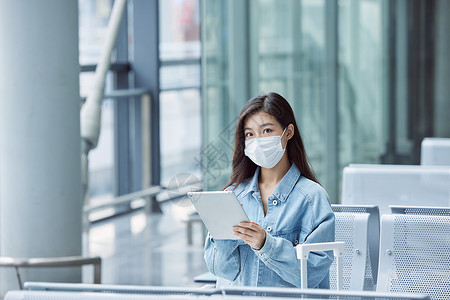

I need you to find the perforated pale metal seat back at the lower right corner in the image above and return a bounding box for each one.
[377,212,450,299]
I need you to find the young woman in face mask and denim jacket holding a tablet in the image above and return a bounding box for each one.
[205,93,334,288]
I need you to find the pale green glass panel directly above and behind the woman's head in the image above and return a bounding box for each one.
[251,0,330,195]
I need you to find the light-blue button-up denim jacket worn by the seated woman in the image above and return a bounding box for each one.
[205,164,334,288]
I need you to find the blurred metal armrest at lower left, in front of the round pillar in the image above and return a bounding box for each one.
[0,256,102,290]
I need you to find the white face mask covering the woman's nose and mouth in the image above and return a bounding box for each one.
[244,128,287,169]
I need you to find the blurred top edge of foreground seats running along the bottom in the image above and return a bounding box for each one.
[12,283,430,300]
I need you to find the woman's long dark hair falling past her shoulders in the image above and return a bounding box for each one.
[227,93,319,187]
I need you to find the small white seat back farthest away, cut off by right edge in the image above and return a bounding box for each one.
[420,138,450,166]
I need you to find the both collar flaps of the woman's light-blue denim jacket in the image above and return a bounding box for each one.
[243,163,301,202]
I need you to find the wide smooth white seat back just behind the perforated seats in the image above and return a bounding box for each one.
[342,164,450,214]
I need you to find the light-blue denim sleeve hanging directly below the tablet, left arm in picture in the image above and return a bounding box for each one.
[204,234,241,281]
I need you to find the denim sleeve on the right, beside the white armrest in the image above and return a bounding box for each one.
[254,190,334,288]
